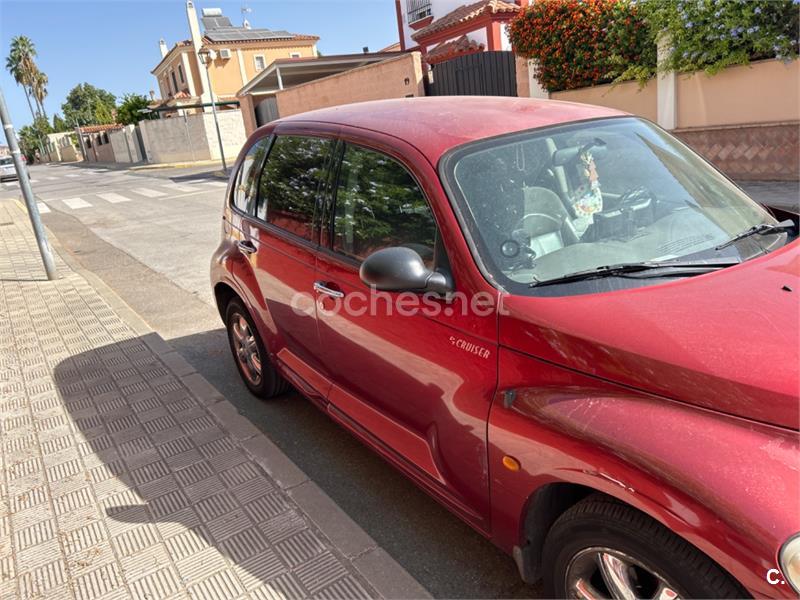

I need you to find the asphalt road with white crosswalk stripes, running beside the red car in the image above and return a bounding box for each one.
[0,165,540,598]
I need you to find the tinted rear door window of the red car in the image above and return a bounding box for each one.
[256,135,331,240]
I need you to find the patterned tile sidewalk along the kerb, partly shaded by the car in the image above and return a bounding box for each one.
[0,201,429,600]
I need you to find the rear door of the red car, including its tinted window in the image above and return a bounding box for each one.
[240,130,334,400]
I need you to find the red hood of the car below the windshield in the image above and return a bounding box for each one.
[500,241,800,429]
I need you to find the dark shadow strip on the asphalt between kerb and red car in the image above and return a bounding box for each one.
[163,327,541,598]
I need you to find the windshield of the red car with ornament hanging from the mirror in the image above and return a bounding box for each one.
[442,118,786,293]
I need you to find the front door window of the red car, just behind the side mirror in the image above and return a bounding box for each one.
[333,145,436,267]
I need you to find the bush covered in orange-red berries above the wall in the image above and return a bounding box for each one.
[508,0,656,92]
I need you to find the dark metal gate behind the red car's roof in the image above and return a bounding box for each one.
[425,52,517,96]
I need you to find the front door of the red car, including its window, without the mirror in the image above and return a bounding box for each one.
[316,138,497,530]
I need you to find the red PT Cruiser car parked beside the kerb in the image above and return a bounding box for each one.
[211,97,800,600]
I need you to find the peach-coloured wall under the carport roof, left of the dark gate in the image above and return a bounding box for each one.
[275,52,425,117]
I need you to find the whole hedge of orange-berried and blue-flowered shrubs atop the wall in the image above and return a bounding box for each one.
[508,0,800,92]
